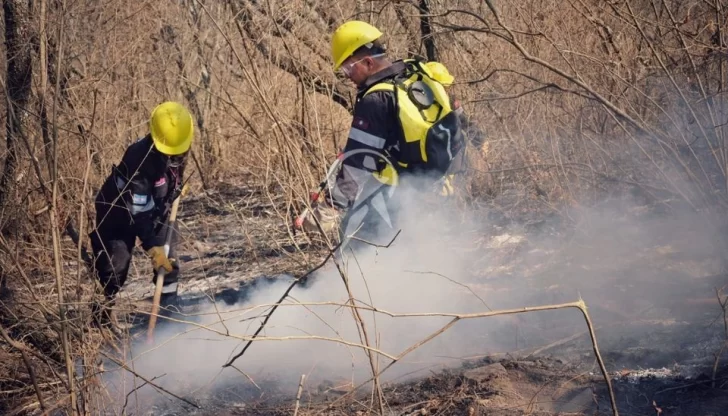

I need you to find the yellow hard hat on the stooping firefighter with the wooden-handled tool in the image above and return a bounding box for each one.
[149,101,195,156]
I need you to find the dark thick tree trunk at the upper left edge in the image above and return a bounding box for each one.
[0,0,33,206]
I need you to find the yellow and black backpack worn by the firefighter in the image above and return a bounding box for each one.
[365,59,465,174]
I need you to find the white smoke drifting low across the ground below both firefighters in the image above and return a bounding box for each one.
[98,172,725,412]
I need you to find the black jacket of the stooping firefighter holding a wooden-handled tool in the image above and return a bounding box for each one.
[96,135,184,250]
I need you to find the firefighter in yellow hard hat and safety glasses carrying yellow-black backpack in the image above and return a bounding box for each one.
[331,21,465,250]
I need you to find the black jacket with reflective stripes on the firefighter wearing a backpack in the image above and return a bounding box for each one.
[334,60,484,205]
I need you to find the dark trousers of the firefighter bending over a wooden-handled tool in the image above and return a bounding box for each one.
[89,206,179,300]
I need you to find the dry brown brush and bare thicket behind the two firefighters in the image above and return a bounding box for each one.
[0,0,728,413]
